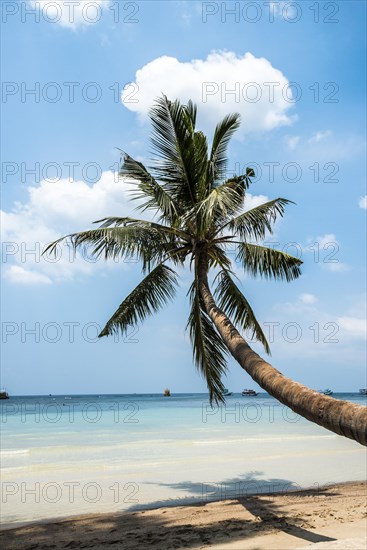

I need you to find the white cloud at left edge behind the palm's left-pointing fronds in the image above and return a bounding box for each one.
[1,172,136,284]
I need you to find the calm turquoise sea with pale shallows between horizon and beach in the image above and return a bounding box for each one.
[0,393,366,523]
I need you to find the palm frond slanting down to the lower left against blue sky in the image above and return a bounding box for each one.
[99,264,177,337]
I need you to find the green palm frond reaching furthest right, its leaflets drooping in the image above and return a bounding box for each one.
[236,243,303,281]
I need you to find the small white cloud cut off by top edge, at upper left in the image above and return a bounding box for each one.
[29,0,111,29]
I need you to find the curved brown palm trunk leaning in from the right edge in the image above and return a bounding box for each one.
[198,251,367,445]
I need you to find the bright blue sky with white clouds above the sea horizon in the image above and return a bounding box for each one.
[1,0,366,394]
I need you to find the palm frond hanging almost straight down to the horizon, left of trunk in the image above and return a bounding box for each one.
[186,282,228,404]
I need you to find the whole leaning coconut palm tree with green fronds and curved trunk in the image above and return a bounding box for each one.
[46,96,367,445]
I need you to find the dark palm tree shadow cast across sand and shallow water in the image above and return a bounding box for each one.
[0,472,338,550]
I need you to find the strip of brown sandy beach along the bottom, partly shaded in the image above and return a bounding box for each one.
[0,482,367,550]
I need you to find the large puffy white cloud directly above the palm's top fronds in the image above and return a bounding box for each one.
[121,51,294,133]
